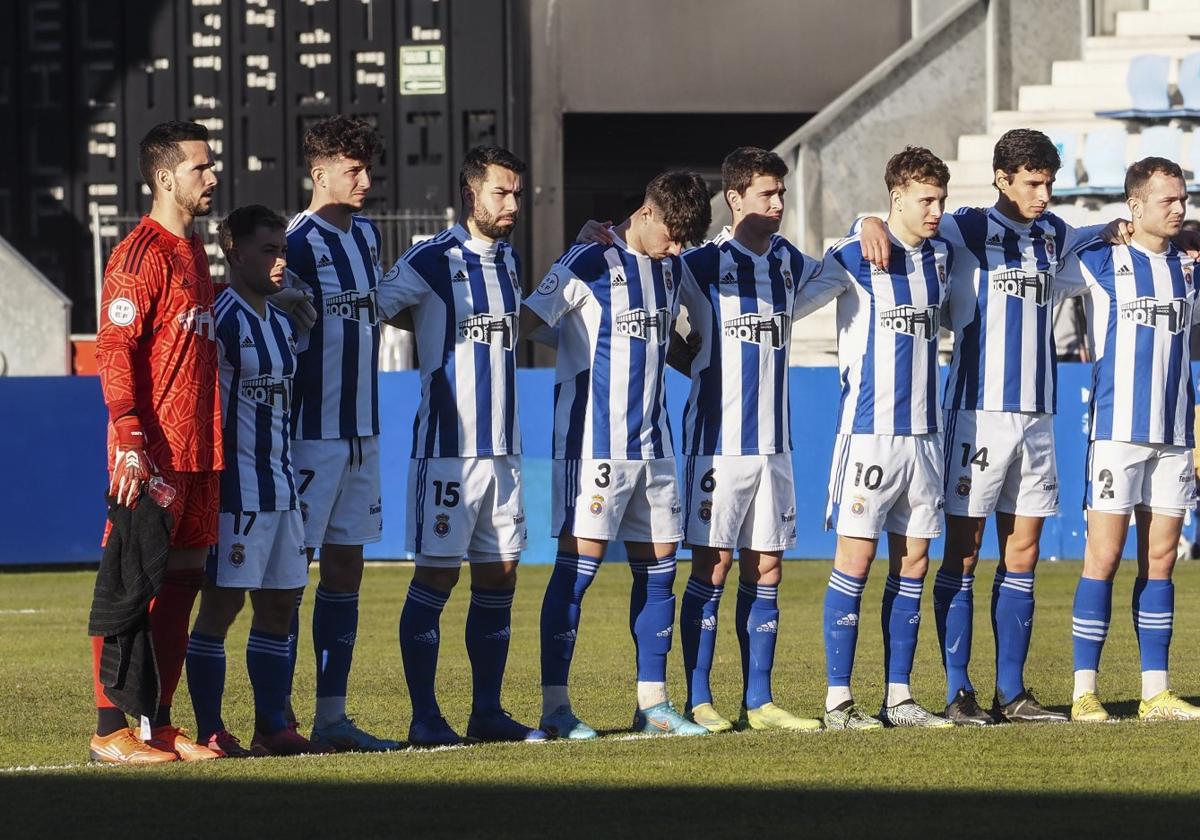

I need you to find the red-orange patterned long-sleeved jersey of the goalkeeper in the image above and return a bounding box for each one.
[96,216,223,472]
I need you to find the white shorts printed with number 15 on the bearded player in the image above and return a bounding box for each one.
[404,455,526,566]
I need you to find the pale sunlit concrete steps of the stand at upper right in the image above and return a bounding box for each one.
[791,0,1200,365]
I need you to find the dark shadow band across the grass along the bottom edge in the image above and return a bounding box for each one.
[0,768,1200,840]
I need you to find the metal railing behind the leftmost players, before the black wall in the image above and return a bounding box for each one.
[90,204,455,333]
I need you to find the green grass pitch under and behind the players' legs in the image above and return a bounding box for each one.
[0,563,1200,839]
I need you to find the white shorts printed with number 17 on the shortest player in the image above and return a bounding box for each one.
[206,510,308,589]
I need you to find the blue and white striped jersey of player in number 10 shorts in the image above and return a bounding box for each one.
[796,226,954,434]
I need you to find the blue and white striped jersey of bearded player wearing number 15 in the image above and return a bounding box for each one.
[378,224,521,458]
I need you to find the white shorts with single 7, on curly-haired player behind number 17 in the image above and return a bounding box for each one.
[292,436,383,548]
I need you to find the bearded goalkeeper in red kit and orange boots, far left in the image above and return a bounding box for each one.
[90,122,223,763]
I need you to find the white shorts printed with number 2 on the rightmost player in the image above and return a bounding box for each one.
[1087,440,1196,516]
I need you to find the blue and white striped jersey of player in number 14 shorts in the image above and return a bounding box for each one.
[938,208,1099,414]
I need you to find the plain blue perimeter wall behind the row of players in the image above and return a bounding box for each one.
[0,364,1161,565]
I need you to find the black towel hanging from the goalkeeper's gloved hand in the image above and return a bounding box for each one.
[88,494,172,718]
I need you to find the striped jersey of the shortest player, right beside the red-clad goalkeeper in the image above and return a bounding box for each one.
[216,288,296,514]
